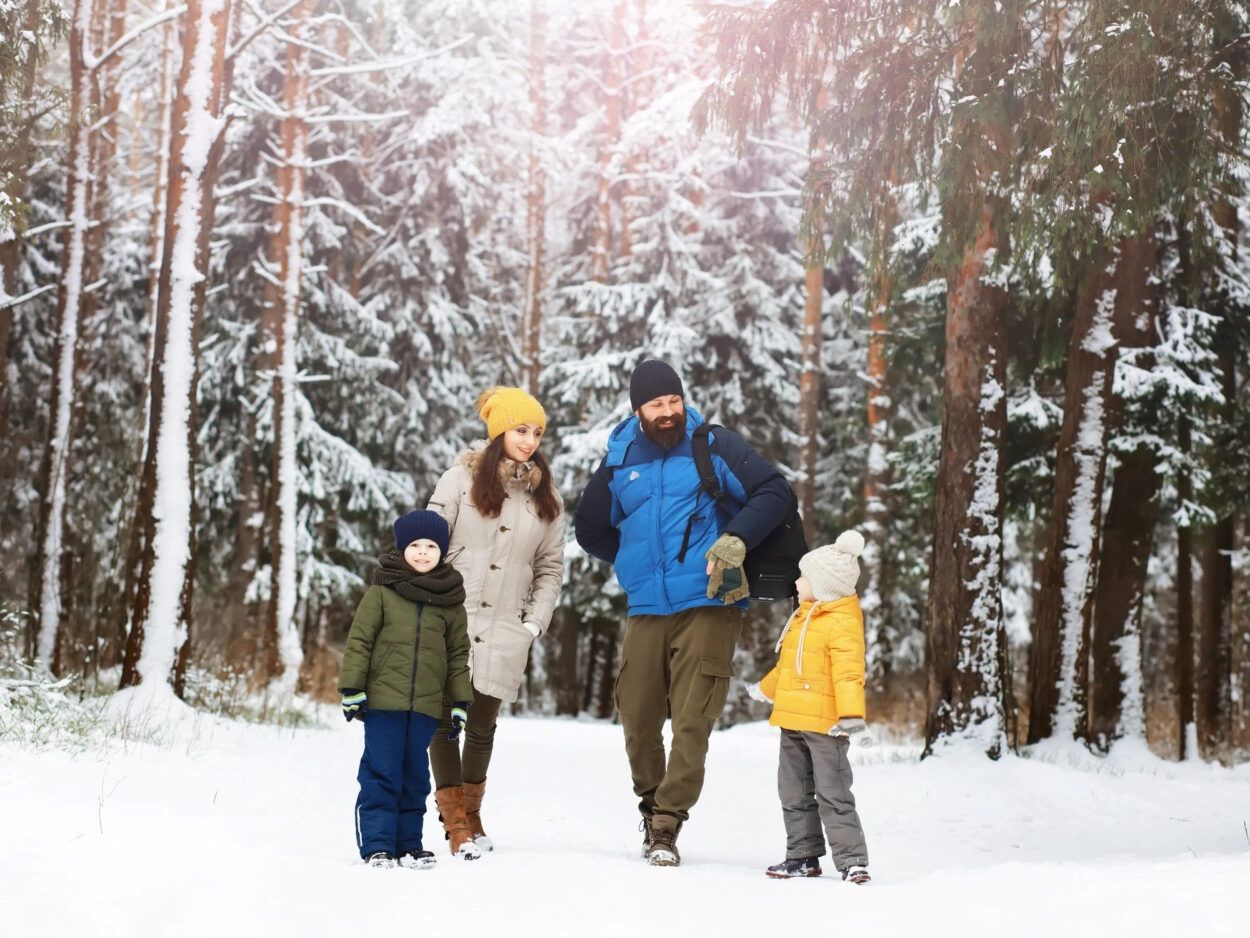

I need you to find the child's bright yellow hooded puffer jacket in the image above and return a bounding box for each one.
[760,594,868,733]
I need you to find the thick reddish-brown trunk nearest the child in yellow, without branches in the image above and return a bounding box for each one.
[925,1,1019,758]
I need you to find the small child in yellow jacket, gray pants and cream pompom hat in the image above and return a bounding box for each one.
[750,530,871,885]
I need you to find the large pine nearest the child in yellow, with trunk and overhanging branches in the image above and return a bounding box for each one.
[708,0,1038,755]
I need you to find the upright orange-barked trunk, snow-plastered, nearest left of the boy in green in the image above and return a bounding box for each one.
[265,0,309,700]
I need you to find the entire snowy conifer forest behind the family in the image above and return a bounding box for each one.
[0,0,1250,762]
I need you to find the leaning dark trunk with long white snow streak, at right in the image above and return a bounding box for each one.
[1028,249,1119,743]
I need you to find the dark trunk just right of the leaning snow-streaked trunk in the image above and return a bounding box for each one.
[1085,233,1161,750]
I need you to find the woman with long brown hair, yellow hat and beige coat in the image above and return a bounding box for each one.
[430,388,565,859]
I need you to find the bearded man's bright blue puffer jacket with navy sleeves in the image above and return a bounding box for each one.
[574,406,791,615]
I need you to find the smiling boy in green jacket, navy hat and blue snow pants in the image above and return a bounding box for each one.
[339,512,473,869]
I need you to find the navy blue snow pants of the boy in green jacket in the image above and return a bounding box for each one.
[356,710,439,858]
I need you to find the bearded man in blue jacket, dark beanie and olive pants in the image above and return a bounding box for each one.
[574,360,793,867]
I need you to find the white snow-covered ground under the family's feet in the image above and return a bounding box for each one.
[0,709,1250,938]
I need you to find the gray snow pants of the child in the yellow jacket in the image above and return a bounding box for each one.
[778,729,868,870]
